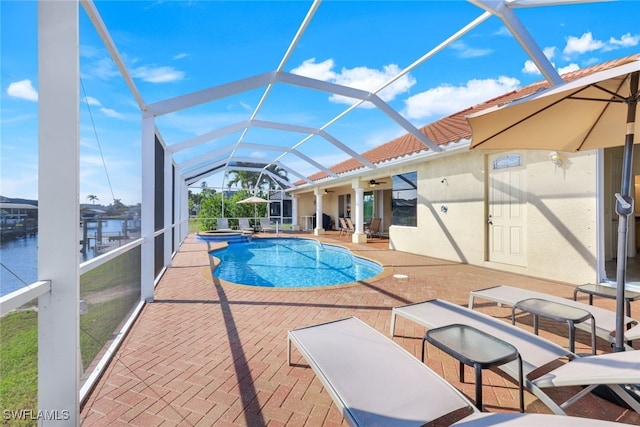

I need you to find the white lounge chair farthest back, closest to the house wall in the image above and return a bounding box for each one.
[469,285,640,349]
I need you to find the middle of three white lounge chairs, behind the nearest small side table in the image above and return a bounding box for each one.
[391,299,640,415]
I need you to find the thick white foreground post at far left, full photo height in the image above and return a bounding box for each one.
[38,1,82,425]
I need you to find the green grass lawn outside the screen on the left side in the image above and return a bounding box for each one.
[0,249,140,420]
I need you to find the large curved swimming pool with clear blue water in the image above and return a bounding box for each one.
[211,238,382,288]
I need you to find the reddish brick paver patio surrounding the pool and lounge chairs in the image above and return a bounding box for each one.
[82,233,640,426]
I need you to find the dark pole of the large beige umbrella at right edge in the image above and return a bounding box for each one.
[613,72,638,352]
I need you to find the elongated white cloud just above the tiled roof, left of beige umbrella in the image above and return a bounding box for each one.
[405,76,520,120]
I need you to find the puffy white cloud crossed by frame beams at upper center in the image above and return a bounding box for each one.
[291,58,416,107]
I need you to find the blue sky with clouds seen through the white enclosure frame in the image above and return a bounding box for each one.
[0,0,640,204]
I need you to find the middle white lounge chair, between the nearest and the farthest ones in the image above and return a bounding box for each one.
[391,299,640,415]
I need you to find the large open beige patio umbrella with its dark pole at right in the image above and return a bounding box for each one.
[467,60,640,351]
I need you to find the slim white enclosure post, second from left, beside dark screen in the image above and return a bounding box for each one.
[140,117,156,302]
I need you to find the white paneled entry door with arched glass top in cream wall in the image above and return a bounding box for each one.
[487,154,527,266]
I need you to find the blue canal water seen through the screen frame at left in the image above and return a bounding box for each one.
[0,219,138,296]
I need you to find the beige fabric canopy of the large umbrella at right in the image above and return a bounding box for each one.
[467,60,640,152]
